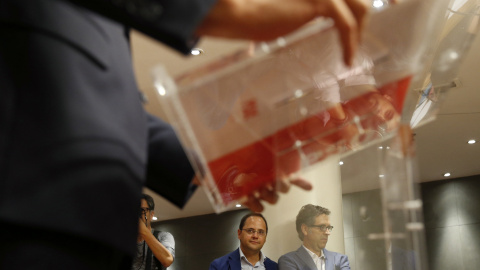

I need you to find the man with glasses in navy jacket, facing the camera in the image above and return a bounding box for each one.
[209,213,278,270]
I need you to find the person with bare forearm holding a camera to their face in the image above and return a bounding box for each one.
[131,194,175,270]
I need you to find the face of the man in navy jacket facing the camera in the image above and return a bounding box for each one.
[238,216,267,253]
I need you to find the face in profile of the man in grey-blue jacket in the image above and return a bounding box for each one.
[302,214,330,253]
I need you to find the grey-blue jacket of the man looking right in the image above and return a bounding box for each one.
[278,246,350,270]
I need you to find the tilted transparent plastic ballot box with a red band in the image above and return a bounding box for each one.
[154,0,450,212]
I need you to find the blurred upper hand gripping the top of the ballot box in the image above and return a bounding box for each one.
[196,0,369,66]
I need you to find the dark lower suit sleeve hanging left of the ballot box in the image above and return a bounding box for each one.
[146,114,196,207]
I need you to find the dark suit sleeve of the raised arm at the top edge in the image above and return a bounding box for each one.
[64,0,217,54]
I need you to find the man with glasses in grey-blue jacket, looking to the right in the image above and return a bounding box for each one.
[278,204,350,270]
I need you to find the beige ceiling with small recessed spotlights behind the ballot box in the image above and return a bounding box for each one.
[132,7,480,220]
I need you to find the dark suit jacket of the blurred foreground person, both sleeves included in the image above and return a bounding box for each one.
[0,0,214,254]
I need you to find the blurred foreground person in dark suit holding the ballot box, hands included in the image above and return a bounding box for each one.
[0,0,367,270]
